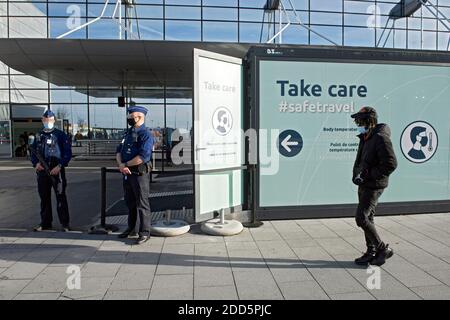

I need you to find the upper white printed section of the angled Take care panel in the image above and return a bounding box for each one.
[194,51,243,170]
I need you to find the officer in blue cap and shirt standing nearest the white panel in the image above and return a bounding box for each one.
[116,106,153,244]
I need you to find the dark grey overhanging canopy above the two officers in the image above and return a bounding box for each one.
[0,39,251,88]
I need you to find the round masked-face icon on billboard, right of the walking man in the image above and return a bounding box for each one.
[400,121,438,163]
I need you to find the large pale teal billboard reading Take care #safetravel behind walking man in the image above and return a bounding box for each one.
[253,46,450,217]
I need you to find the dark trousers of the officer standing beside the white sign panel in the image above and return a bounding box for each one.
[123,172,151,236]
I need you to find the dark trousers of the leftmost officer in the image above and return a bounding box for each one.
[37,168,70,228]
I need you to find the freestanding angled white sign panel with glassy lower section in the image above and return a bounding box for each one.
[194,50,244,221]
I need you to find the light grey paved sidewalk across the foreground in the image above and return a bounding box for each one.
[0,214,450,300]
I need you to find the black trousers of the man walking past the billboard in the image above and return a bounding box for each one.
[355,186,384,250]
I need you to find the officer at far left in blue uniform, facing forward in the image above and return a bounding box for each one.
[31,110,72,231]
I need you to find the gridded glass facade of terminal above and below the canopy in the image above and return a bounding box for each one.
[0,0,450,155]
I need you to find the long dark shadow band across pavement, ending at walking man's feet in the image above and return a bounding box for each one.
[0,230,365,269]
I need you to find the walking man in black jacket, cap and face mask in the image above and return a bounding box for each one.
[351,107,397,266]
